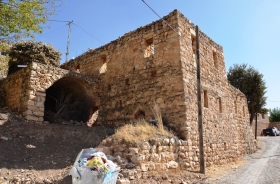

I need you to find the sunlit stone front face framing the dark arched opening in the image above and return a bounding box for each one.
[23,62,99,122]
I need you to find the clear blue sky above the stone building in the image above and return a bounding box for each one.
[35,0,280,108]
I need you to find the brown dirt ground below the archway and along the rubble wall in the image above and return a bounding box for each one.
[0,109,210,184]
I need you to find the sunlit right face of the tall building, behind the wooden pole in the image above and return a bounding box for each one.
[179,13,255,165]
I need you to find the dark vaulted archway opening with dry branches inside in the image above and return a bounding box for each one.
[44,77,98,123]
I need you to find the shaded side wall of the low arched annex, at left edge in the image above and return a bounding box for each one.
[0,66,31,113]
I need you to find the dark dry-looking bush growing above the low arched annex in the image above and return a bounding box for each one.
[8,41,61,75]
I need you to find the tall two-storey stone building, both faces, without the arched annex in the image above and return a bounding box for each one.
[62,10,256,165]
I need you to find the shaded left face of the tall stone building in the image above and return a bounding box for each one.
[62,11,186,130]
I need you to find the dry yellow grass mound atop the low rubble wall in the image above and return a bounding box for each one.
[114,120,175,143]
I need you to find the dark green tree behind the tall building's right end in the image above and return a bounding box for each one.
[227,64,266,124]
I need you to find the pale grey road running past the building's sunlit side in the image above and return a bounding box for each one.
[211,136,280,184]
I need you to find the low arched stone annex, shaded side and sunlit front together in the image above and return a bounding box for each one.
[0,62,99,122]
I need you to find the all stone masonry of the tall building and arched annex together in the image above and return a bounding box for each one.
[0,10,256,171]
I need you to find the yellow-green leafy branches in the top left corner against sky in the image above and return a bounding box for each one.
[0,0,61,42]
